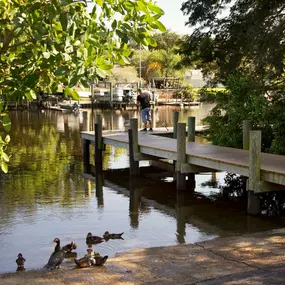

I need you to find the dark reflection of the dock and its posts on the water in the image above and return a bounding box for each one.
[84,167,274,243]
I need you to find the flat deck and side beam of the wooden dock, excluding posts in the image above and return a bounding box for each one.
[82,130,285,185]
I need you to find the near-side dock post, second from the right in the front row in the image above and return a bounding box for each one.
[175,123,186,190]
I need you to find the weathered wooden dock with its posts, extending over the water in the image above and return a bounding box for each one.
[82,112,285,214]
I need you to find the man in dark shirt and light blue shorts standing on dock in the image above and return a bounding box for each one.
[137,89,153,132]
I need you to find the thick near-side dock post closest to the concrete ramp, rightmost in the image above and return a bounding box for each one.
[247,131,261,215]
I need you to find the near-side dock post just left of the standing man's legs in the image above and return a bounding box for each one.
[128,118,140,175]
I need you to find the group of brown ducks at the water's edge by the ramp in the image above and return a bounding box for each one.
[16,232,123,271]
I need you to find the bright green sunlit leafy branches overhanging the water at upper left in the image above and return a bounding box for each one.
[0,0,165,172]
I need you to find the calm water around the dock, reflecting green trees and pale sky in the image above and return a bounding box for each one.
[0,105,279,273]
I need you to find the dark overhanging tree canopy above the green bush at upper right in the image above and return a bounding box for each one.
[181,0,285,84]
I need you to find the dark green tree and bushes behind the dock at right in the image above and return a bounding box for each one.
[180,0,285,154]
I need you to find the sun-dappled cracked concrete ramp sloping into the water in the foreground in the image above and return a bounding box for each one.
[0,229,285,285]
